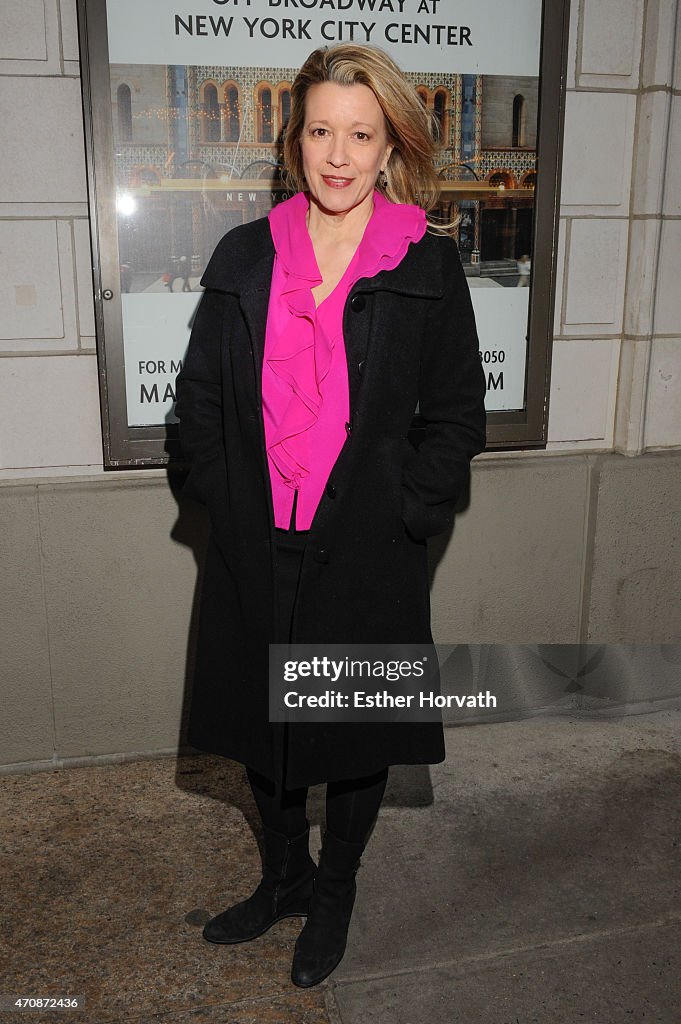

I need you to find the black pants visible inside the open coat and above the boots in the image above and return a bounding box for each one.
[247,512,388,843]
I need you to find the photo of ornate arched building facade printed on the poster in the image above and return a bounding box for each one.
[111,65,539,293]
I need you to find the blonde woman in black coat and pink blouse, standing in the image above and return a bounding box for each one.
[177,44,485,986]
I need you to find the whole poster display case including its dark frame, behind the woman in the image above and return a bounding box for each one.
[79,0,567,466]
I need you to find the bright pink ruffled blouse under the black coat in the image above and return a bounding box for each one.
[262,191,426,529]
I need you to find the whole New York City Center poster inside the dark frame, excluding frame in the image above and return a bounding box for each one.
[99,0,542,427]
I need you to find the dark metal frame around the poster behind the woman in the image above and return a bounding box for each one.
[78,0,569,469]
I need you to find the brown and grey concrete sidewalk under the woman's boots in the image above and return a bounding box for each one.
[0,712,681,1024]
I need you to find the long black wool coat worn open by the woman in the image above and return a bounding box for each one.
[176,211,485,787]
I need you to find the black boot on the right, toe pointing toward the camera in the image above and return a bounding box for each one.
[291,829,366,988]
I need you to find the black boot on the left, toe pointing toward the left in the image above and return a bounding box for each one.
[204,825,316,944]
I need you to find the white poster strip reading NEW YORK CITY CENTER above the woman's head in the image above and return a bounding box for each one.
[108,0,542,76]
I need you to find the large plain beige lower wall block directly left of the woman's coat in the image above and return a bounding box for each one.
[41,476,201,757]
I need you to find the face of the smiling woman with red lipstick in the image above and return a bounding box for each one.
[301,82,392,215]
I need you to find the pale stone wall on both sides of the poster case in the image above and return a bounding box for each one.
[0,0,681,767]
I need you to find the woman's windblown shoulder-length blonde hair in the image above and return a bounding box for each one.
[284,43,439,211]
